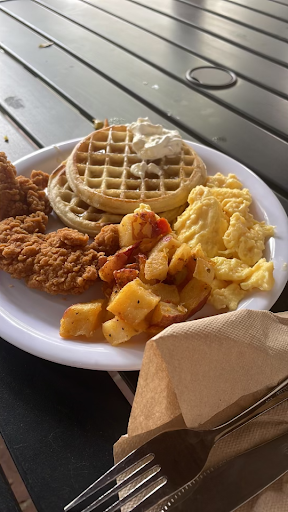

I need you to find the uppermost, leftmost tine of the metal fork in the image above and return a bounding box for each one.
[64,446,154,512]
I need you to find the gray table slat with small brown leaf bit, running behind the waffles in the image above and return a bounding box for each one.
[0,15,195,140]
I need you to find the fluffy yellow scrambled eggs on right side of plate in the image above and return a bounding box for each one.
[174,173,274,310]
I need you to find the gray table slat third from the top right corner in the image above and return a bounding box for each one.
[130,0,287,58]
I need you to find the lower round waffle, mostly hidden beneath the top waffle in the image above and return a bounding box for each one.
[48,162,186,236]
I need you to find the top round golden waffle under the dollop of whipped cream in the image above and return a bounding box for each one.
[66,125,206,215]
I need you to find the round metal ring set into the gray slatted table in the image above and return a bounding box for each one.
[186,66,237,89]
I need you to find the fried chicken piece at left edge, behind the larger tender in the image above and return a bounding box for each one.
[0,152,52,221]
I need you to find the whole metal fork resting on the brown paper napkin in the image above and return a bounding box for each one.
[64,378,288,512]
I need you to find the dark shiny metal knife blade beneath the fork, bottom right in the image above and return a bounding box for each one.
[157,432,288,512]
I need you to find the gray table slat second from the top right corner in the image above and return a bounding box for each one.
[177,0,288,37]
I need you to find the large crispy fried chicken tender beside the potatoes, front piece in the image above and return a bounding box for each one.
[0,212,103,295]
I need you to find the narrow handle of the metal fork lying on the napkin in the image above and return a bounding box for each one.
[212,379,288,443]
